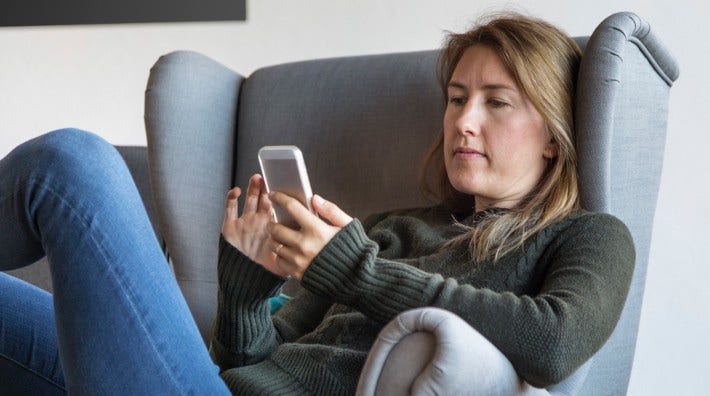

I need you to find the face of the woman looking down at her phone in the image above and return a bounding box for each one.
[444,45,557,211]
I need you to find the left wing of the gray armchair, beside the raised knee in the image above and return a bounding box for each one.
[145,51,242,342]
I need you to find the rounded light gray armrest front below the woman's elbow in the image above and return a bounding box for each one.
[357,308,546,395]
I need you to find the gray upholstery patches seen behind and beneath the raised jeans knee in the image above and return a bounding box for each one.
[7,146,163,292]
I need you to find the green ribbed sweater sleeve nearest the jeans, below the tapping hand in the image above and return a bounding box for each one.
[210,238,284,370]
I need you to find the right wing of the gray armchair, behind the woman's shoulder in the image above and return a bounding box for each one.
[576,13,678,395]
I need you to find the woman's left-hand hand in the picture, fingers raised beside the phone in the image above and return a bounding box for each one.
[222,174,288,277]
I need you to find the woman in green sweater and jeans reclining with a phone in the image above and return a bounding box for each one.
[0,12,634,395]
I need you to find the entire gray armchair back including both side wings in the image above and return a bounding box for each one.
[145,10,677,394]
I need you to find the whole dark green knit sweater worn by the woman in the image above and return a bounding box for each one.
[210,207,634,395]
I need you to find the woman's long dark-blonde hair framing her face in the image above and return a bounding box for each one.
[422,14,581,261]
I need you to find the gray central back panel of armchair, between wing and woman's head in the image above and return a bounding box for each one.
[235,51,444,218]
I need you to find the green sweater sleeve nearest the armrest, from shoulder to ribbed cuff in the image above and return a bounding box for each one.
[302,215,634,387]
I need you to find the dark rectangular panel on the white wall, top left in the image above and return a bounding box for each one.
[0,0,246,26]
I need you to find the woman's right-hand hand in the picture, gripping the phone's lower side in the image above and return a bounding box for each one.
[268,192,352,280]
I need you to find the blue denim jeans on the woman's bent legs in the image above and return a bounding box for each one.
[0,129,229,395]
